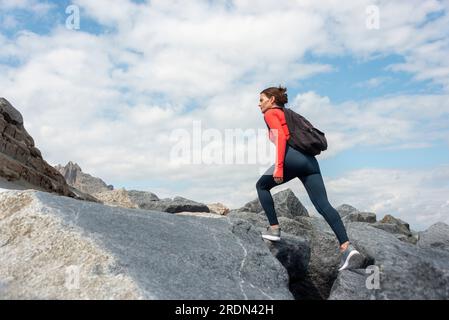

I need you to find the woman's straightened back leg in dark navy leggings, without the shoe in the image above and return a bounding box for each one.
[299,173,349,245]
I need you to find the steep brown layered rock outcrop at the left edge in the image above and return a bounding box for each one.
[0,98,75,197]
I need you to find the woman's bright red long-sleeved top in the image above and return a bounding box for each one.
[264,108,290,177]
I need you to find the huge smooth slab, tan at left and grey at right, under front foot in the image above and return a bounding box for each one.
[0,190,293,300]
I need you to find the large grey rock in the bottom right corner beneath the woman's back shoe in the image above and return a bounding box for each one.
[329,222,449,300]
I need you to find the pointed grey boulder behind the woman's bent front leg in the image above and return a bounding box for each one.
[231,189,309,218]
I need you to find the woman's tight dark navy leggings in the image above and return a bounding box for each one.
[256,144,348,244]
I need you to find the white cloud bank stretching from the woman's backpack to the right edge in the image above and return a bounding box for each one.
[292,92,449,159]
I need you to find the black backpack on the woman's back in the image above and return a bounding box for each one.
[267,107,327,156]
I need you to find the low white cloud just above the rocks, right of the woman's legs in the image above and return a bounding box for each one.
[326,165,449,230]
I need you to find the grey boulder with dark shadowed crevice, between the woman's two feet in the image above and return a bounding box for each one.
[229,205,354,300]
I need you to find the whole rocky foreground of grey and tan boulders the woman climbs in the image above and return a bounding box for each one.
[0,185,449,299]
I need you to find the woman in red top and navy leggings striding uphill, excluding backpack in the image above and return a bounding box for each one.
[256,86,361,271]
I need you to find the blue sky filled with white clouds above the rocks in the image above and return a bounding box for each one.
[0,0,449,230]
